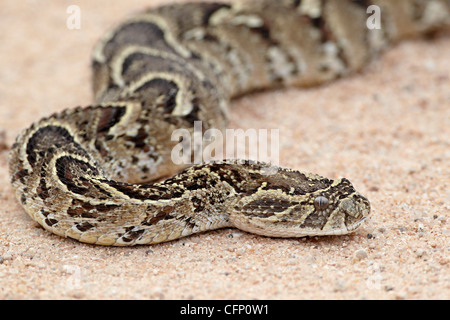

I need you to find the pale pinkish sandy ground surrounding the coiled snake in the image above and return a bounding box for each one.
[0,0,450,299]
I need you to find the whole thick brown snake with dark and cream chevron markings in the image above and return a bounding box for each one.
[9,0,450,246]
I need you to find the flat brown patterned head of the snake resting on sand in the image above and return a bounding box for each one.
[230,171,370,237]
